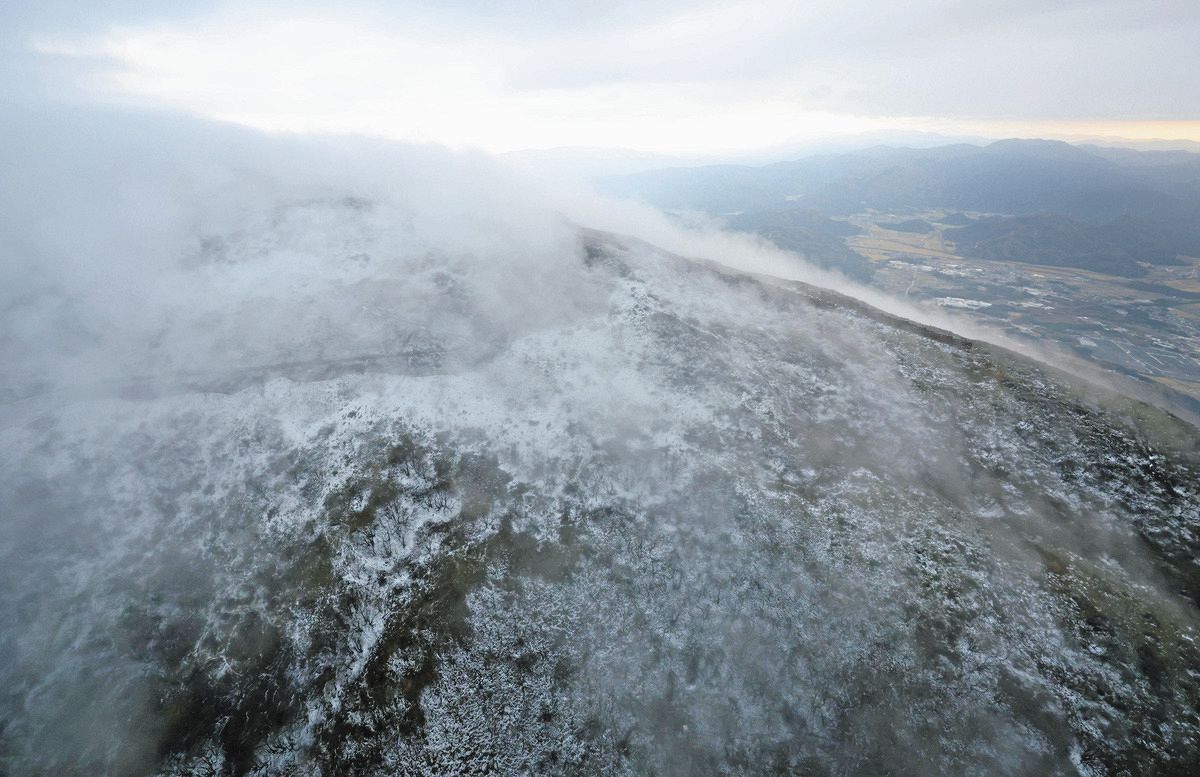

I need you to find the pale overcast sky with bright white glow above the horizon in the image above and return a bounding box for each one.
[0,0,1200,153]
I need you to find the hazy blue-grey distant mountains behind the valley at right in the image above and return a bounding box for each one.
[599,140,1200,277]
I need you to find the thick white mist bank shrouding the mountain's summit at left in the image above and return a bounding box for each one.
[0,102,600,402]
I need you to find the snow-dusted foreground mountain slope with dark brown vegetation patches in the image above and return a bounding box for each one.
[0,199,1200,775]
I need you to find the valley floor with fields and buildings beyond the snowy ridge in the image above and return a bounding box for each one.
[846,211,1200,410]
